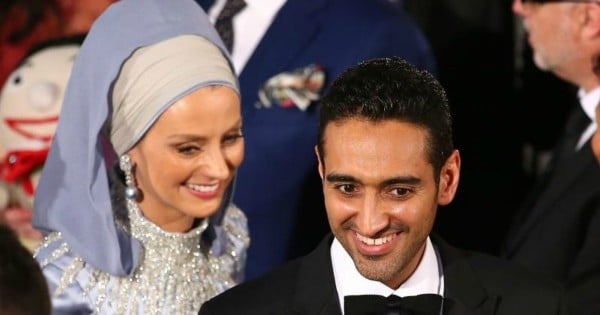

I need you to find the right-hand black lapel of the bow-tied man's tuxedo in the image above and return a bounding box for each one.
[431,235,499,315]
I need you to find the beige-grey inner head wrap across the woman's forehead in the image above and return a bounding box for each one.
[110,35,237,156]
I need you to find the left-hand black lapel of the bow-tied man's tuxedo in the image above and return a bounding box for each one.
[290,234,342,315]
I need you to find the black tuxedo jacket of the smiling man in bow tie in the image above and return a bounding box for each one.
[199,234,566,315]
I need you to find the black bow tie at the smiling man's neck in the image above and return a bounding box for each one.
[344,294,442,315]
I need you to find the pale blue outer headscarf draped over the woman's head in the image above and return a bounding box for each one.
[33,0,238,276]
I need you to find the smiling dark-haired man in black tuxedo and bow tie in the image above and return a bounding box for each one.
[200,58,564,315]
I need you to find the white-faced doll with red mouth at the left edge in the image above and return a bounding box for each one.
[0,36,83,248]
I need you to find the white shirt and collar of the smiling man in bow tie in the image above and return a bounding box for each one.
[331,238,444,312]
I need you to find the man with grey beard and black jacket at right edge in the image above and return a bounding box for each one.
[501,0,600,315]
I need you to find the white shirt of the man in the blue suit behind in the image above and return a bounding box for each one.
[207,0,285,75]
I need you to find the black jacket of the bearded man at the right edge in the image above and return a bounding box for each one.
[502,141,600,315]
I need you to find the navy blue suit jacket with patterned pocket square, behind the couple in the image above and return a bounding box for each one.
[197,0,435,279]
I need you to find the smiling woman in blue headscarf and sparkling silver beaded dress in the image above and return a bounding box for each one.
[33,0,249,314]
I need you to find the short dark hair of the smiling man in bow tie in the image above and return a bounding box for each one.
[318,58,454,180]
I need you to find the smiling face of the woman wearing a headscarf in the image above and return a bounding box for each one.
[128,86,244,232]
